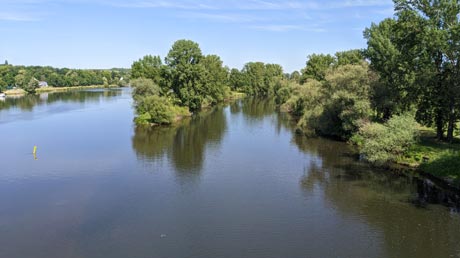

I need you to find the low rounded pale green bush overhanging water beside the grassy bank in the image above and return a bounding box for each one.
[351,113,419,165]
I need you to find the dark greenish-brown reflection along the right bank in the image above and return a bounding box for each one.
[294,136,460,257]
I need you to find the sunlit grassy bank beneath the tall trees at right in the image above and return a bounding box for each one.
[398,128,460,185]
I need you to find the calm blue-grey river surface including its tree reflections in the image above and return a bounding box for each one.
[0,90,460,258]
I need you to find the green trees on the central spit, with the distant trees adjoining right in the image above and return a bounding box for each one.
[131,40,284,124]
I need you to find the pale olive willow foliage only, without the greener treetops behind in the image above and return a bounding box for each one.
[277,61,372,139]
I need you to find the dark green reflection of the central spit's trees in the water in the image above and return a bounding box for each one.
[132,106,227,176]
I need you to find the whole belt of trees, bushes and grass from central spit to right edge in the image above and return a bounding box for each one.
[132,0,460,184]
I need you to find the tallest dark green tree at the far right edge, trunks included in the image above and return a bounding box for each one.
[394,0,460,141]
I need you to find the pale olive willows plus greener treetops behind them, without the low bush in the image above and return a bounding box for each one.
[276,50,374,139]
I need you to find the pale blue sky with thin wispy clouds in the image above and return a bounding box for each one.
[0,0,393,72]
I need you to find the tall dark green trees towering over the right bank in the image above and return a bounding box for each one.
[364,0,460,142]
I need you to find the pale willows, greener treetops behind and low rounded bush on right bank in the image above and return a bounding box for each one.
[275,50,418,163]
